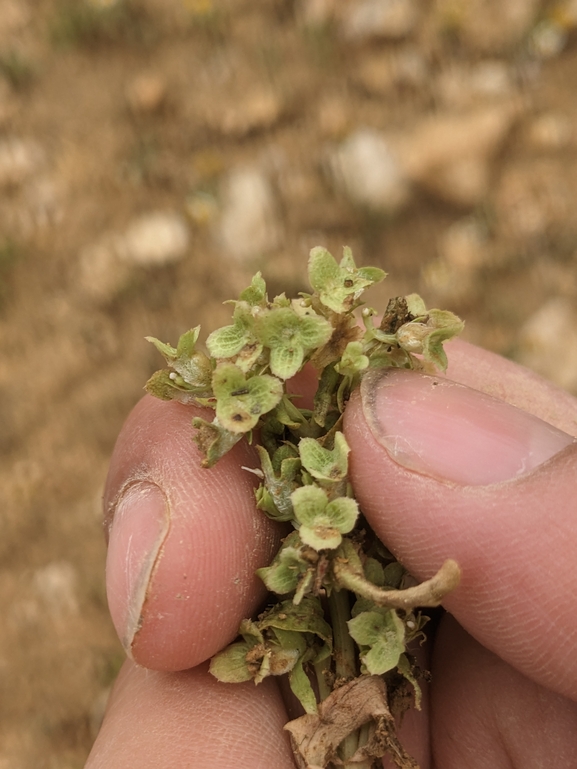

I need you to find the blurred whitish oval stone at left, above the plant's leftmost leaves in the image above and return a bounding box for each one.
[117,211,190,267]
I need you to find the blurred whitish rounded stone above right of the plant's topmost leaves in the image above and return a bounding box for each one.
[329,128,409,211]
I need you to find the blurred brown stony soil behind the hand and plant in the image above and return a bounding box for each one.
[0,0,577,769]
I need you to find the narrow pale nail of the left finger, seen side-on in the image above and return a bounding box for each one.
[106,481,170,656]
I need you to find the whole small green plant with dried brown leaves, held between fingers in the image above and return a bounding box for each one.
[146,246,463,769]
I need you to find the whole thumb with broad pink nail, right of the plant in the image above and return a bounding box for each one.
[345,353,577,698]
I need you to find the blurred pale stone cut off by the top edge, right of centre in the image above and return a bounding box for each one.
[341,0,420,41]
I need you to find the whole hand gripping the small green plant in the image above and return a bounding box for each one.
[87,341,577,769]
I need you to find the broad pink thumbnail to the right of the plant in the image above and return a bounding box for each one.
[361,369,575,486]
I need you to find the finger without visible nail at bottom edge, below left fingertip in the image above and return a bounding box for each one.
[86,661,294,769]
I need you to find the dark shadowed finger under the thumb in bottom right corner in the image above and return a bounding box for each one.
[431,616,577,769]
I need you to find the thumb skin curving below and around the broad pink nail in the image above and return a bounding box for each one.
[345,346,577,698]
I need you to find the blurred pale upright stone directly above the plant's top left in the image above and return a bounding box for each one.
[216,166,281,260]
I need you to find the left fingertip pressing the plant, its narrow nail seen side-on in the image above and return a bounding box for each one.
[104,396,281,670]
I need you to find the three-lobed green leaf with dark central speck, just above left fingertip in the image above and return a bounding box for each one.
[212,363,284,433]
